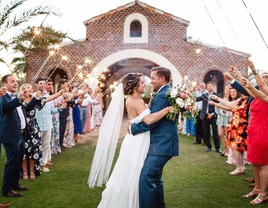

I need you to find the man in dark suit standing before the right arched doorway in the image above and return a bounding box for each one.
[196,82,222,153]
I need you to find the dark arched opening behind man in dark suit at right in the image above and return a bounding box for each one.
[204,70,224,95]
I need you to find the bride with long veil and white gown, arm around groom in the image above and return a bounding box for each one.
[88,73,174,208]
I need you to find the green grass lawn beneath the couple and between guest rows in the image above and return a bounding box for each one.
[0,135,267,208]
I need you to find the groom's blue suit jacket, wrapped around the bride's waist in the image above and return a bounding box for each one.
[131,85,179,156]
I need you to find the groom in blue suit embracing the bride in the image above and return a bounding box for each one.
[130,67,179,208]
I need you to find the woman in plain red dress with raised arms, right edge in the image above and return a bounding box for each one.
[238,66,268,204]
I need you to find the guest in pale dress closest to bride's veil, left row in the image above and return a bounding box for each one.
[91,88,104,129]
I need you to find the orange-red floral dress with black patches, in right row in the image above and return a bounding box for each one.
[227,103,248,152]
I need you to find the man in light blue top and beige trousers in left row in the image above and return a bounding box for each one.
[33,78,66,172]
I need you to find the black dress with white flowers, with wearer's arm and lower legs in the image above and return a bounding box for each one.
[23,98,46,176]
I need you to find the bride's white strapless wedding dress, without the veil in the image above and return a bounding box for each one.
[98,109,150,208]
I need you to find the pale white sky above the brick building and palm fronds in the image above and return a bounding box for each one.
[0,0,268,75]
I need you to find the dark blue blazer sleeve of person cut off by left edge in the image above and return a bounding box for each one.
[0,98,21,143]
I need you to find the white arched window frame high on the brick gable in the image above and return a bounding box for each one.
[124,13,148,43]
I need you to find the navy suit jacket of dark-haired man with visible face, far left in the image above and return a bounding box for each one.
[2,94,38,144]
